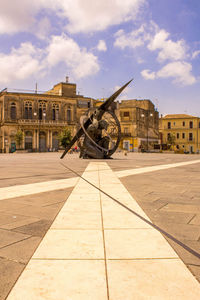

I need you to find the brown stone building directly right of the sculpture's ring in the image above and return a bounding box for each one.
[119,99,159,151]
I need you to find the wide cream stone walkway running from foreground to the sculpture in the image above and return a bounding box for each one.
[7,162,200,300]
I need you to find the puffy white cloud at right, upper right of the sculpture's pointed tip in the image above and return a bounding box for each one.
[148,29,187,62]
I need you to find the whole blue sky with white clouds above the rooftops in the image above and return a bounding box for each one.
[0,0,200,117]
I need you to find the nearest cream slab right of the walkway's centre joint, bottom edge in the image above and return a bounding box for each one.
[108,259,199,300]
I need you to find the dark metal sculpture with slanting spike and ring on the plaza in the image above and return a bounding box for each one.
[60,80,132,159]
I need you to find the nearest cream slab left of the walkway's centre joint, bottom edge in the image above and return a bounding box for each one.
[7,260,107,300]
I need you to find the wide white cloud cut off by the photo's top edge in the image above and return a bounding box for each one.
[0,0,146,34]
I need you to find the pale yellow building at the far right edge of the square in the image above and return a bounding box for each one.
[159,114,200,153]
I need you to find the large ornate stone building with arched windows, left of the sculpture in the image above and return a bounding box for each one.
[0,82,94,152]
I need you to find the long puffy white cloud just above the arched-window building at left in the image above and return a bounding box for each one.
[0,34,100,84]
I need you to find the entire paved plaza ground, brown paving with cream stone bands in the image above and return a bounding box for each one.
[0,153,200,300]
